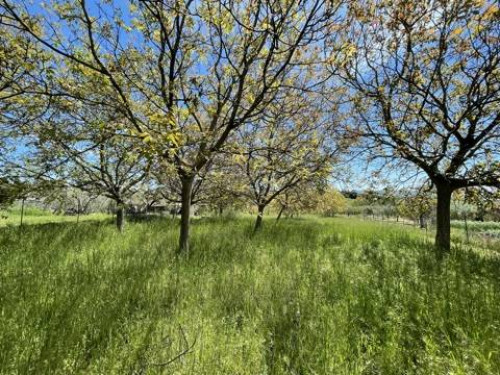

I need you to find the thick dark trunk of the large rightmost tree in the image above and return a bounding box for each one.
[436,183,453,253]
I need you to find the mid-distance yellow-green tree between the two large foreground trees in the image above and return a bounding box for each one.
[234,96,337,231]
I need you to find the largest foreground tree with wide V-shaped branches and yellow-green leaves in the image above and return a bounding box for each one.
[1,0,342,251]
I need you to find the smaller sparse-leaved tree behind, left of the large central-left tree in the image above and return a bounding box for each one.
[35,111,150,232]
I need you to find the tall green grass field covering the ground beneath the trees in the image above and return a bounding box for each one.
[0,218,500,374]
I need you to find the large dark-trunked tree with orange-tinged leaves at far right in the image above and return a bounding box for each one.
[332,0,500,254]
